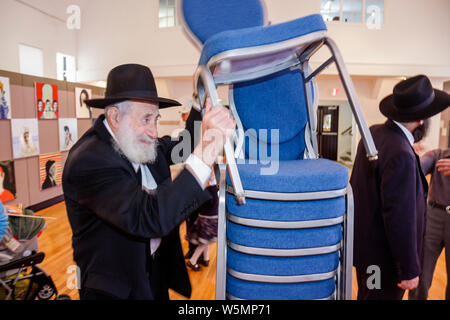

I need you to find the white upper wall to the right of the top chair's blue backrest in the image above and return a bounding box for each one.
[266,0,450,78]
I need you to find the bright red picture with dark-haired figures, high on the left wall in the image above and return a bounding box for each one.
[35,82,59,119]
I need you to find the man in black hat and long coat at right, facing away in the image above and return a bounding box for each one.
[350,75,450,300]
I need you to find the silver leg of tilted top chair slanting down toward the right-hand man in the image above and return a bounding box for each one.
[325,38,378,160]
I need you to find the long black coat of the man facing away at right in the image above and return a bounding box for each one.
[350,120,428,281]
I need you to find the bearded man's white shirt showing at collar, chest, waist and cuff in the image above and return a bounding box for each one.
[103,119,212,254]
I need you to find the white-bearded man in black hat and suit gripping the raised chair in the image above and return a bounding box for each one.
[63,64,235,299]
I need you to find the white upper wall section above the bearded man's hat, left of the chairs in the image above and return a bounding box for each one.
[78,0,199,81]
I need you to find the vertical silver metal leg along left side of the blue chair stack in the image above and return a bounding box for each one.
[216,164,227,300]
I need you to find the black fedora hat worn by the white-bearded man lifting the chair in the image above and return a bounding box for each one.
[85,64,181,109]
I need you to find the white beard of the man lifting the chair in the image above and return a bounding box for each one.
[114,119,158,163]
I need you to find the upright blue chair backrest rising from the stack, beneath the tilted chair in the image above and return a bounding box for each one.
[233,70,308,160]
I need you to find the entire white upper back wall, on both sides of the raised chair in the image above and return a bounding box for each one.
[78,0,450,81]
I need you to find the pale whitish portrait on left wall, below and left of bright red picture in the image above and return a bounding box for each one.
[11,119,39,159]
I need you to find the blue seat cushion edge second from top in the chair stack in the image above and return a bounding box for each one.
[226,193,346,221]
